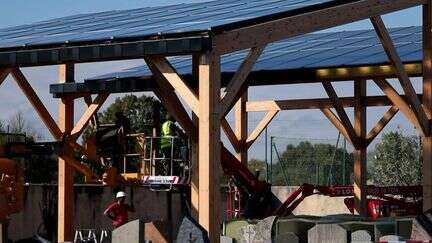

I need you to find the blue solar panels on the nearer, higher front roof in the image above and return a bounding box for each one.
[0,0,337,49]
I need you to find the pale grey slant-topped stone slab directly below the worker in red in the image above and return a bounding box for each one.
[111,219,144,243]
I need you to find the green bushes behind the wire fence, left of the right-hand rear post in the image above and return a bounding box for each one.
[271,142,354,185]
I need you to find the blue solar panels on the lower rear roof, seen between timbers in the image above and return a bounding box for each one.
[90,26,422,80]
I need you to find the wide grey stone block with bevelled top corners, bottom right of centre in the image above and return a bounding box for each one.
[308,224,348,243]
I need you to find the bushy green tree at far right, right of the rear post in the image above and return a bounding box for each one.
[371,131,422,186]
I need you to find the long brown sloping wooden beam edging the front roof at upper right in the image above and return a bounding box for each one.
[213,0,426,54]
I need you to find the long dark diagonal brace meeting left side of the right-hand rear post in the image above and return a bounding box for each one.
[322,82,358,147]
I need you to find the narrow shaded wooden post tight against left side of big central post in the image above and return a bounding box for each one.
[190,54,200,221]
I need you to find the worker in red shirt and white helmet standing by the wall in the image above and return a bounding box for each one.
[104,191,135,228]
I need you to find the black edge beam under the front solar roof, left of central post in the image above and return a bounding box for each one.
[0,36,211,68]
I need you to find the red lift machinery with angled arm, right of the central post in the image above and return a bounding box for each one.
[221,146,422,219]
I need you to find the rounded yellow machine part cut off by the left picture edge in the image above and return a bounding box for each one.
[0,158,24,222]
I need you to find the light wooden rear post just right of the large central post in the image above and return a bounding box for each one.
[234,89,248,165]
